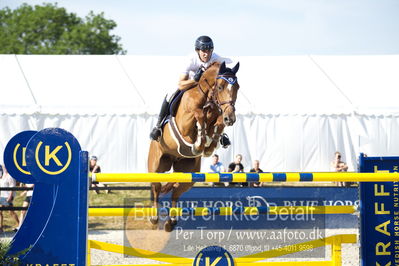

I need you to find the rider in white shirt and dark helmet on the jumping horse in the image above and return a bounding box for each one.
[150,36,232,148]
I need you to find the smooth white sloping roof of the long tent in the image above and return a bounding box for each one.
[0,55,399,115]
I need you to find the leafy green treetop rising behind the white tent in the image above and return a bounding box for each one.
[0,4,126,54]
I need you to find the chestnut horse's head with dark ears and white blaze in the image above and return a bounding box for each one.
[214,62,240,126]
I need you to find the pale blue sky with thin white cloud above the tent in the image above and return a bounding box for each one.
[0,0,399,56]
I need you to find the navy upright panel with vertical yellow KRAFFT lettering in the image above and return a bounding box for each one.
[360,154,399,265]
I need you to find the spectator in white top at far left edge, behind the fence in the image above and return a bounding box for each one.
[0,165,19,232]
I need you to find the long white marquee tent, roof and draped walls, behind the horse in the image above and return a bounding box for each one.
[0,55,399,172]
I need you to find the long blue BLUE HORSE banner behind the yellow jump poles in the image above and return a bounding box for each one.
[155,187,359,229]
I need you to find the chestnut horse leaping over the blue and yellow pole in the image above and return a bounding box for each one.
[148,62,240,232]
